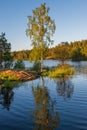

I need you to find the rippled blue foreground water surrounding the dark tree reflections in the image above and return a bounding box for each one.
[0,75,87,130]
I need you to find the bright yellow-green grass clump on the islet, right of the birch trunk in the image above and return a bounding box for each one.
[48,64,74,78]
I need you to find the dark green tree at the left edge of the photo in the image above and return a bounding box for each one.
[0,33,12,68]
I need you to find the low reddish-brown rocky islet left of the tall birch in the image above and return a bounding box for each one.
[0,69,38,81]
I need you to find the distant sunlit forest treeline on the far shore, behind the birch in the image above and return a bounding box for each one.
[11,40,87,61]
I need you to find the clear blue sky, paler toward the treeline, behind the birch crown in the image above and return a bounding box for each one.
[0,0,87,51]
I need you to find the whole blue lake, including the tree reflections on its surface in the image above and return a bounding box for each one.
[0,60,87,130]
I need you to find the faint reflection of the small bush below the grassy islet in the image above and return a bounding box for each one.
[55,77,74,99]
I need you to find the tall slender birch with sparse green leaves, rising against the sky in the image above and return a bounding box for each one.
[26,3,55,71]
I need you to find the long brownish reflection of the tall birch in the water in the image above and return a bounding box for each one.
[32,78,60,130]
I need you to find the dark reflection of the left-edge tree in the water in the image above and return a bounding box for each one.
[0,86,14,110]
